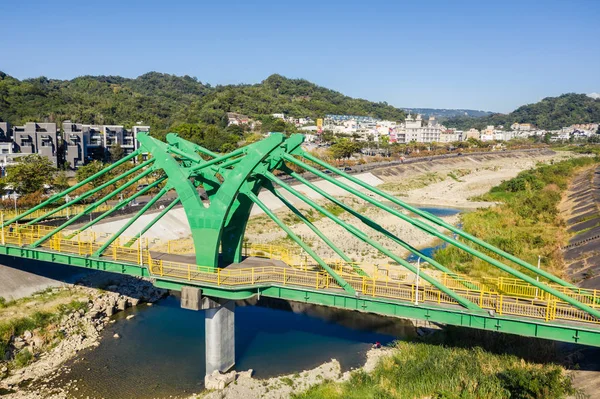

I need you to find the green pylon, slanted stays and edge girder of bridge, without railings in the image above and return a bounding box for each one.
[0,133,600,346]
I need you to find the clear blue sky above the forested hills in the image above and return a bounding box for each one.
[0,0,600,112]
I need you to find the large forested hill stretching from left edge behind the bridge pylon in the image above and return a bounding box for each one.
[0,72,404,131]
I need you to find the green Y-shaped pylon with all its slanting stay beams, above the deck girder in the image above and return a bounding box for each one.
[3,133,600,319]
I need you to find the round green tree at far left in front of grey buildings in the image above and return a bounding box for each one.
[6,154,57,195]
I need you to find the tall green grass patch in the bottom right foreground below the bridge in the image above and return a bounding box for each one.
[292,342,576,399]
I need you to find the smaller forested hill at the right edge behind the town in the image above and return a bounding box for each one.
[444,93,600,130]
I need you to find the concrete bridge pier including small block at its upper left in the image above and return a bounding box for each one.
[181,287,235,376]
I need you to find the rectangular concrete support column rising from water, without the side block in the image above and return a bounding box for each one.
[202,298,235,375]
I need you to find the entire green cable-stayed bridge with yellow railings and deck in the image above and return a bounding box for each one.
[0,133,600,371]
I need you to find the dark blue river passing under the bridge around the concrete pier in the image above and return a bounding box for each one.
[45,208,460,399]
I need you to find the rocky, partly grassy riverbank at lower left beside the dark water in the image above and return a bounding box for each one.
[0,273,167,399]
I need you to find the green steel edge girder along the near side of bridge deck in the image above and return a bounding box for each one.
[0,241,600,347]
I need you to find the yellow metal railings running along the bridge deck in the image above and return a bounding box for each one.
[1,225,600,323]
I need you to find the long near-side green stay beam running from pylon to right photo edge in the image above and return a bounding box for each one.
[283,154,600,320]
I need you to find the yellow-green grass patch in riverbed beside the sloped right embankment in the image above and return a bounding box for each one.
[434,157,600,277]
